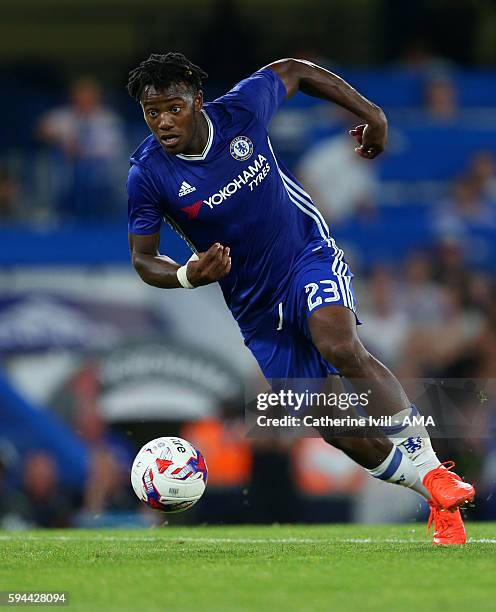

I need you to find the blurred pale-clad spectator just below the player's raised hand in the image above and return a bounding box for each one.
[296,113,378,225]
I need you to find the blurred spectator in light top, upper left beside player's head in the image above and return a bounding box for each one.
[38,78,127,219]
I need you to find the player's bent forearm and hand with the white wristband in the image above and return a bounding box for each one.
[129,233,231,289]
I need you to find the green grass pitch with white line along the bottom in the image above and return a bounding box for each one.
[0,523,496,612]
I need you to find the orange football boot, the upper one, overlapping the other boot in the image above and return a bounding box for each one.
[423,461,475,510]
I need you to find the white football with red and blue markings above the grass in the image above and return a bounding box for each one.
[131,437,207,512]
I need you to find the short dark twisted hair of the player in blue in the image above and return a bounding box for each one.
[127,52,208,102]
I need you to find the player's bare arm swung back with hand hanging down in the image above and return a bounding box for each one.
[265,58,387,159]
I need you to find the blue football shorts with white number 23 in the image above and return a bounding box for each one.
[241,241,360,379]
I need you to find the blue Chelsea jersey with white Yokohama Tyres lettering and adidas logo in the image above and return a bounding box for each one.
[127,69,342,329]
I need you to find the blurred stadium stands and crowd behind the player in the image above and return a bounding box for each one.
[0,0,496,529]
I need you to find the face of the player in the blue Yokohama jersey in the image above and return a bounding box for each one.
[141,83,203,155]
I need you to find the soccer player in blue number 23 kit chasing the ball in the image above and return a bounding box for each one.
[127,53,475,544]
